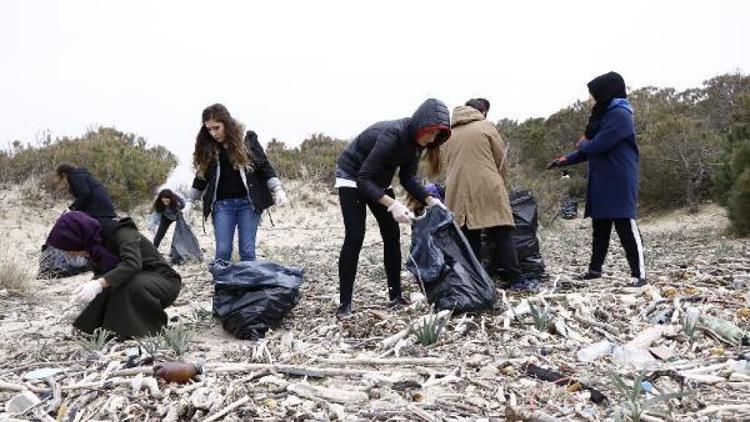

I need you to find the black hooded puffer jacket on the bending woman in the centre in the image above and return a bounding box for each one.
[337,98,450,203]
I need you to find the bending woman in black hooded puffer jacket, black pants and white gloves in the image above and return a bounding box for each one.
[335,98,450,317]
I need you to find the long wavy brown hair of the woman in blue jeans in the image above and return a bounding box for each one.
[193,104,252,178]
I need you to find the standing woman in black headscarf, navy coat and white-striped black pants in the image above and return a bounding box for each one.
[547,72,646,286]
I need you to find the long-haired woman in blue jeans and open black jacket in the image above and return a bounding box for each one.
[190,104,287,261]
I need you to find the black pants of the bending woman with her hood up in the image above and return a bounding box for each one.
[339,187,401,303]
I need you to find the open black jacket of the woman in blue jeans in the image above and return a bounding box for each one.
[191,130,277,218]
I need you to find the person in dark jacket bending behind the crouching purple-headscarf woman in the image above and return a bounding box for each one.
[56,164,116,220]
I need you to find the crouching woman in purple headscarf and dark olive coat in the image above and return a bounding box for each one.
[46,211,182,339]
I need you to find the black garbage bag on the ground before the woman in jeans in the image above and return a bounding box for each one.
[209,260,303,340]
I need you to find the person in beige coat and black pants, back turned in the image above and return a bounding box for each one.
[442,98,529,290]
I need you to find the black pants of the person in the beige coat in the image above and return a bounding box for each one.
[461,226,521,283]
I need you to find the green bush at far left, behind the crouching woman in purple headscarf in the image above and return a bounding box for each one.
[0,127,177,210]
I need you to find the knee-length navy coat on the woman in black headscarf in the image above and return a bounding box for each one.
[565,98,639,219]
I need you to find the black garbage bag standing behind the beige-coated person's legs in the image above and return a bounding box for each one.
[482,190,546,280]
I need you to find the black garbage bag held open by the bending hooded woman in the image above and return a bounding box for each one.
[406,207,495,313]
